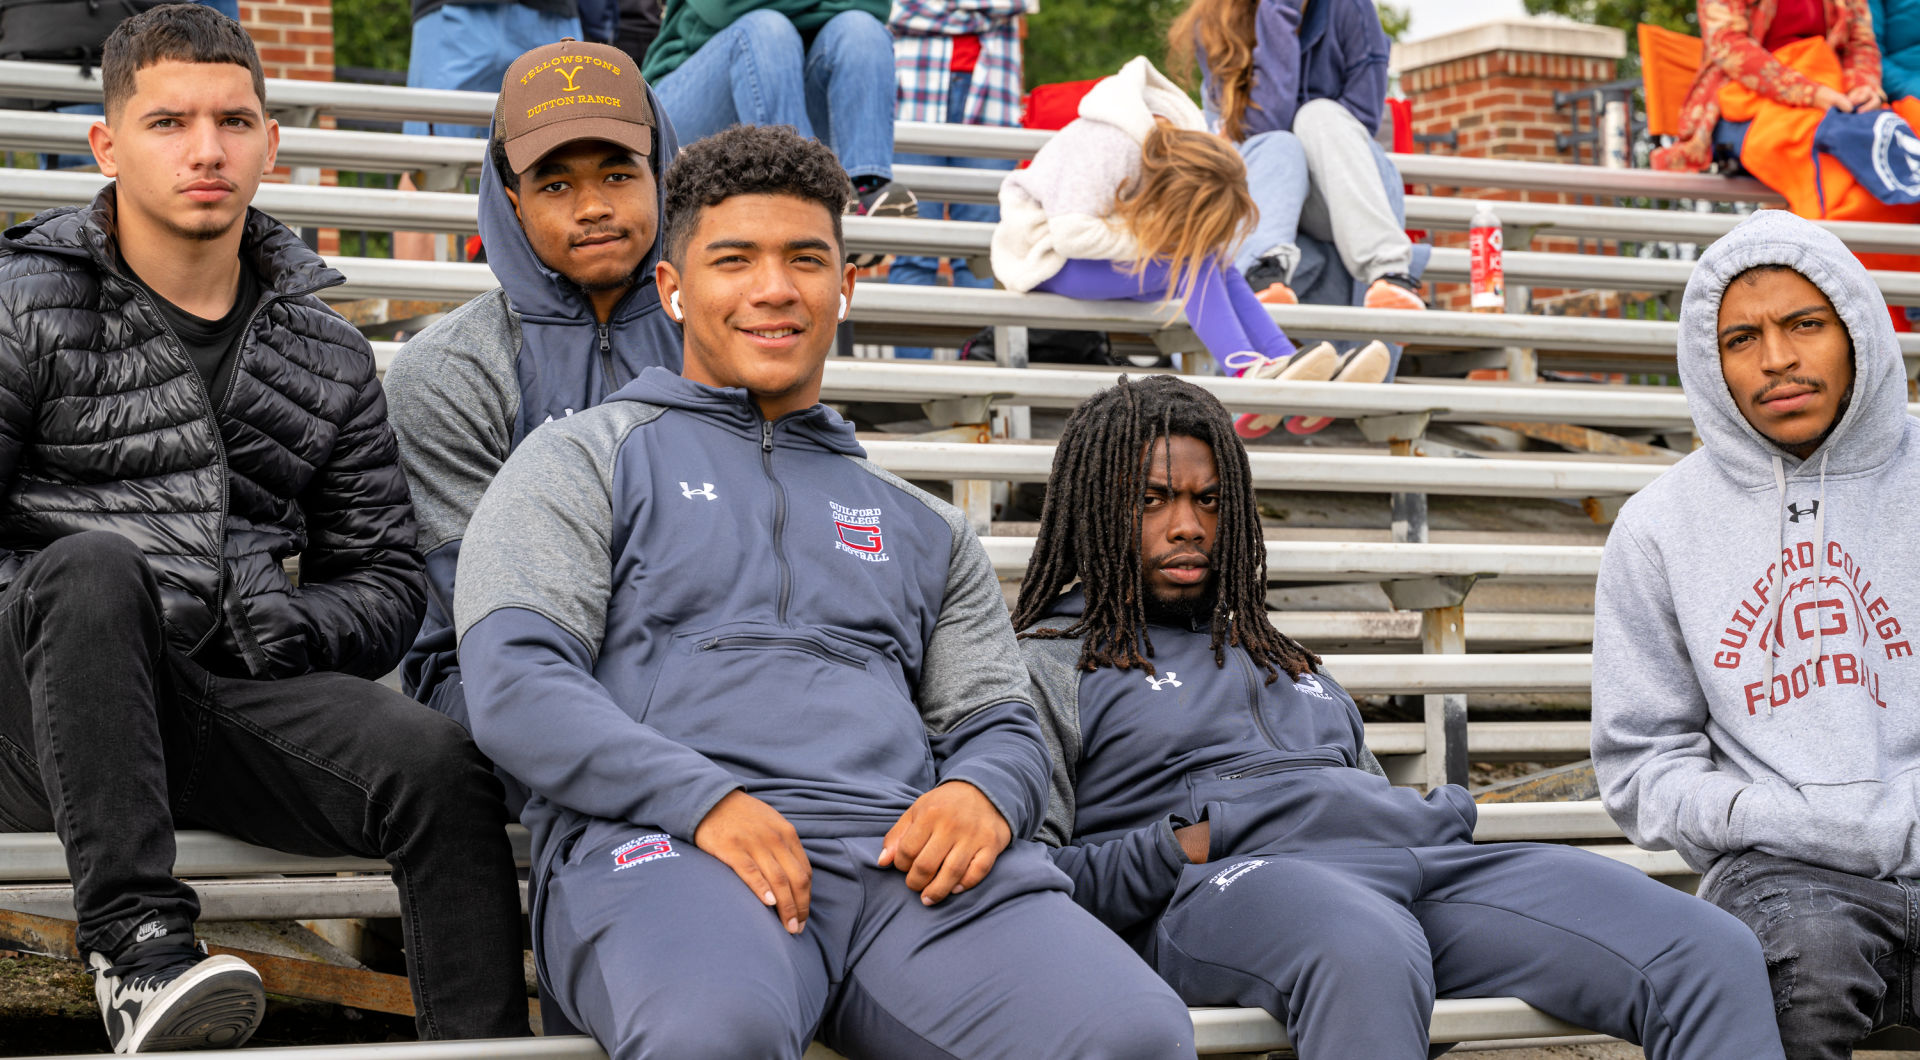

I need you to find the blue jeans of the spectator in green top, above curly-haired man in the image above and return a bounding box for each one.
[653,10,895,179]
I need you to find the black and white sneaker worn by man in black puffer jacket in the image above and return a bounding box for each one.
[86,937,267,1052]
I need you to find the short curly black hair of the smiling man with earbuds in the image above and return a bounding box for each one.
[664,125,852,265]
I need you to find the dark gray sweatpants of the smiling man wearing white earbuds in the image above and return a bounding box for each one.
[536,822,1194,1060]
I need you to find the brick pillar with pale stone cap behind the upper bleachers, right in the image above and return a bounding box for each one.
[1394,19,1626,315]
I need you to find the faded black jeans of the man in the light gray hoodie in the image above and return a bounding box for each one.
[1701,851,1920,1060]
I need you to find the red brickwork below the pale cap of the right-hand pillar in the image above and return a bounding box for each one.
[1400,52,1617,309]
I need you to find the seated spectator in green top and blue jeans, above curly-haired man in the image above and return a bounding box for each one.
[645,0,918,261]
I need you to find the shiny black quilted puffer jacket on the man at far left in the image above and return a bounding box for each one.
[0,184,426,678]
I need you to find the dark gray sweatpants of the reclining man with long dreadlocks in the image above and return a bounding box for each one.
[1146,843,1782,1060]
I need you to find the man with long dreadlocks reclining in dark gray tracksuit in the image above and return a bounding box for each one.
[1014,376,1782,1060]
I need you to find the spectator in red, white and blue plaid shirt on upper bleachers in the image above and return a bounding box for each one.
[887,0,1027,359]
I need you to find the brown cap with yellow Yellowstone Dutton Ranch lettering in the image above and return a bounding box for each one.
[493,36,653,173]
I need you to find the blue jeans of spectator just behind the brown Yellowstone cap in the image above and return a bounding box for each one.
[405,4,580,138]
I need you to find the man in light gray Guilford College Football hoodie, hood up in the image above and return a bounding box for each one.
[1594,209,1920,1058]
